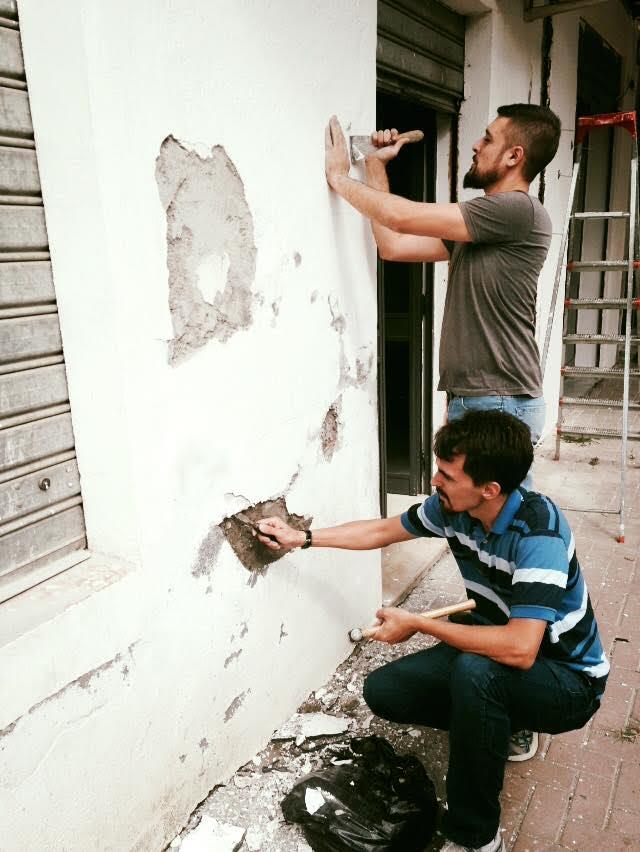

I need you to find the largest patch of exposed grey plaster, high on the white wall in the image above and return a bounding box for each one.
[156,136,256,365]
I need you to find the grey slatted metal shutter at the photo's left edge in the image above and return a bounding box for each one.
[0,5,86,601]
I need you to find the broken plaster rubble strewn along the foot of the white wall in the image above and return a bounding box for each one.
[169,556,462,852]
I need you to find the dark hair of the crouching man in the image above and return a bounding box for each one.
[433,411,533,494]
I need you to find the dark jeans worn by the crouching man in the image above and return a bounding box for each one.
[364,642,599,847]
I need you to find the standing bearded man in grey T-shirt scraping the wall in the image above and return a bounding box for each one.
[325,104,560,444]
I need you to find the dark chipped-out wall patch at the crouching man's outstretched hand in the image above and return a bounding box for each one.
[220,497,312,582]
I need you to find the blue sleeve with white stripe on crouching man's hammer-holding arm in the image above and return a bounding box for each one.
[511,530,569,622]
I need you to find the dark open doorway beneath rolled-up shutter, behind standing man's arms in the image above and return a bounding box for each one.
[377,93,435,506]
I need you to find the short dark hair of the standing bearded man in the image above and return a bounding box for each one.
[498,104,560,182]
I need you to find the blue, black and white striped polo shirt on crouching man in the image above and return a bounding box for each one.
[401,488,609,697]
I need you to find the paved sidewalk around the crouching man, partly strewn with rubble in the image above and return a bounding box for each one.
[172,438,640,852]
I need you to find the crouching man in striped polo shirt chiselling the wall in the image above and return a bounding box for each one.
[254,411,609,852]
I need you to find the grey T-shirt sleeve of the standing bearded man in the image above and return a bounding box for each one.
[458,192,533,243]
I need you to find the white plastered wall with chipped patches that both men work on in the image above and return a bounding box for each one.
[0,0,380,852]
